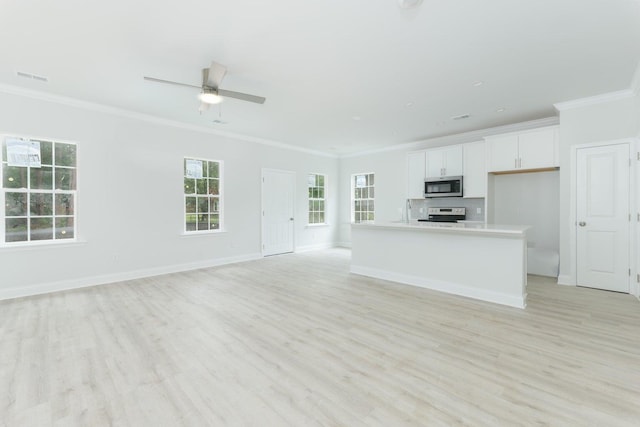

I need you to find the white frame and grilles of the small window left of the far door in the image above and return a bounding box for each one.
[182,156,224,235]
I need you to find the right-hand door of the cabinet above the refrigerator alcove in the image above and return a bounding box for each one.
[519,128,558,169]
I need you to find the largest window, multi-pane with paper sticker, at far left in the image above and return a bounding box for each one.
[0,136,77,243]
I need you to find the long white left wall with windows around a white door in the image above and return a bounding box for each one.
[0,94,339,298]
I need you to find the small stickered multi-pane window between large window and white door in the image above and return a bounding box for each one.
[184,158,222,232]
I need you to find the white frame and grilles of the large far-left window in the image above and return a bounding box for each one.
[0,134,79,247]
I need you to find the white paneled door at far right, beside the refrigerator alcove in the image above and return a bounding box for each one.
[576,144,630,293]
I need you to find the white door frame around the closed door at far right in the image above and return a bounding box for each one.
[560,138,640,296]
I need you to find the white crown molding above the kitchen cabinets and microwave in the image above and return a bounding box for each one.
[340,117,560,159]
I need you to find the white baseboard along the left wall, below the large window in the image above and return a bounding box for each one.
[0,253,262,301]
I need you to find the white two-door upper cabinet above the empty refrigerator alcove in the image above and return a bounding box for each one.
[485,126,560,172]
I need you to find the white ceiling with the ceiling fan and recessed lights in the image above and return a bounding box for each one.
[0,0,640,155]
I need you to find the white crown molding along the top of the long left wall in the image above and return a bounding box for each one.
[0,84,338,158]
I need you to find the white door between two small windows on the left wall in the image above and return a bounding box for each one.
[262,169,296,256]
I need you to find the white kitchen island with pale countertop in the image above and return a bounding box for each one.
[351,221,529,308]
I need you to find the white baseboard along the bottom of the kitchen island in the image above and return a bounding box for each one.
[351,265,527,308]
